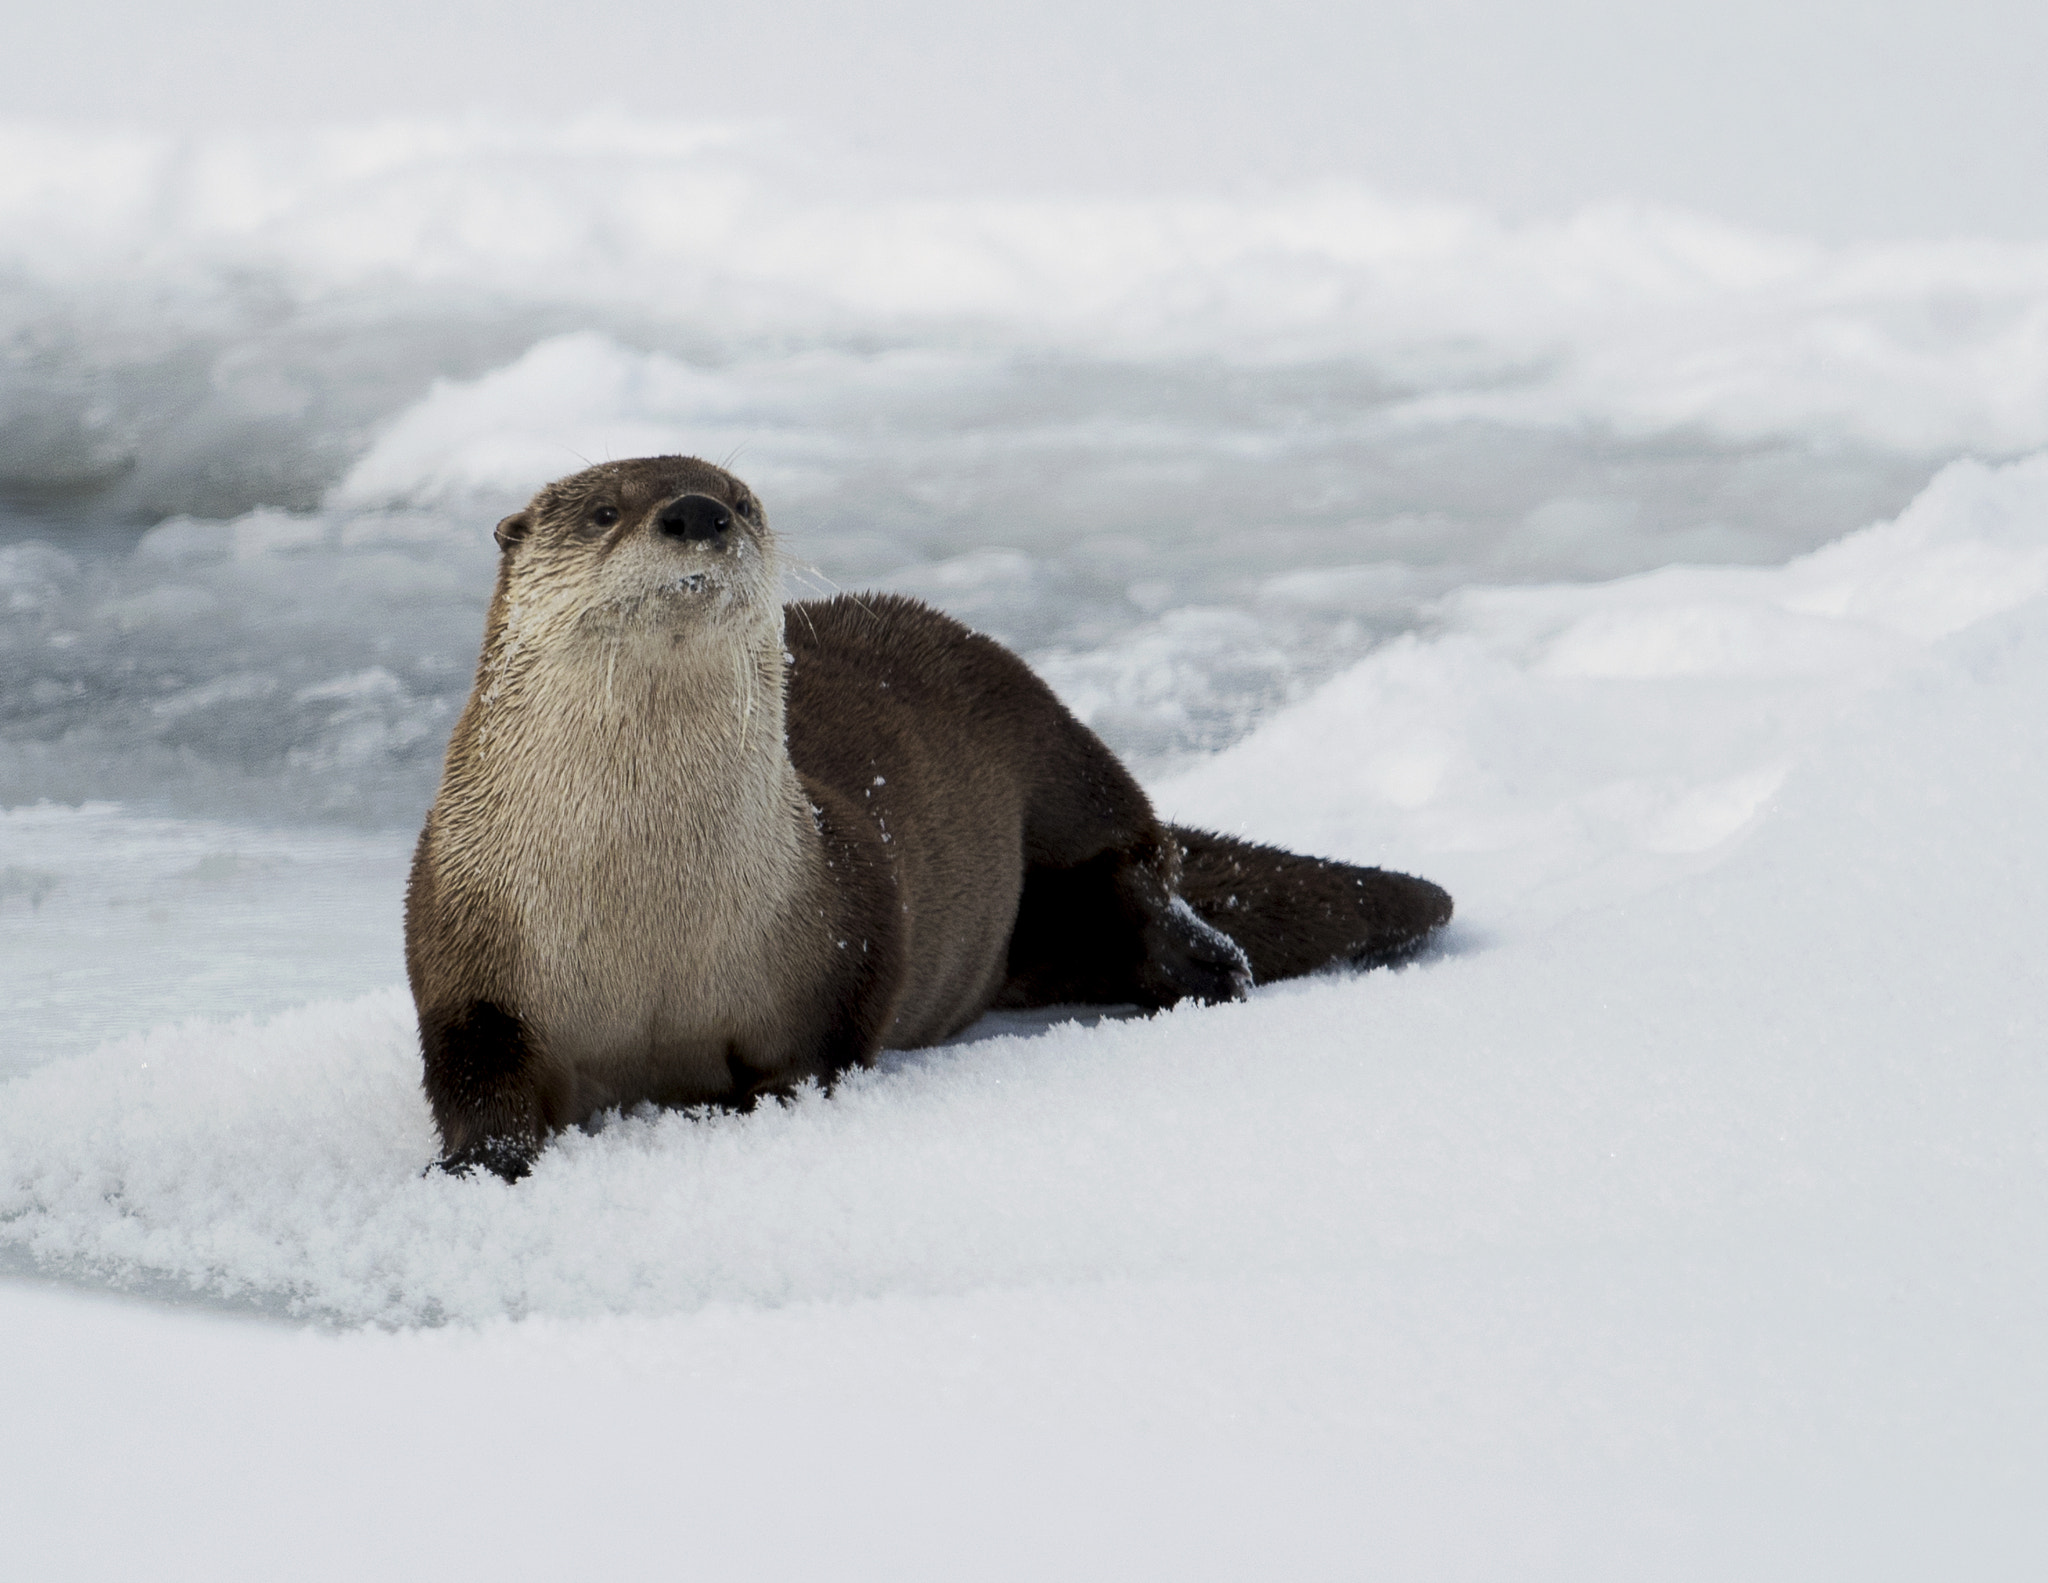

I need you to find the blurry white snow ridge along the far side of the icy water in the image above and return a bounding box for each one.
[12,121,2048,485]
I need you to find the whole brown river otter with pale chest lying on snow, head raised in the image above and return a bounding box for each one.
[406,457,1450,1180]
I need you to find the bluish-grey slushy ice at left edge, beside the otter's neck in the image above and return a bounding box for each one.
[0,499,492,823]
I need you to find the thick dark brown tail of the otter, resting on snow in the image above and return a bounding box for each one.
[1174,825,1450,983]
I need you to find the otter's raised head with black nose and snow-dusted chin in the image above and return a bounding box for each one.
[498,457,780,645]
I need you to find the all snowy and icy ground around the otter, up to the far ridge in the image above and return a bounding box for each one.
[0,111,2048,1579]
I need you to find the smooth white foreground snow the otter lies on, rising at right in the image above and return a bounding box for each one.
[0,459,2048,1577]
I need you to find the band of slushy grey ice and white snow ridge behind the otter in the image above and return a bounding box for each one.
[0,123,2048,825]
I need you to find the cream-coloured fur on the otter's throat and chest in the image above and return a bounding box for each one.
[436,618,821,1102]
